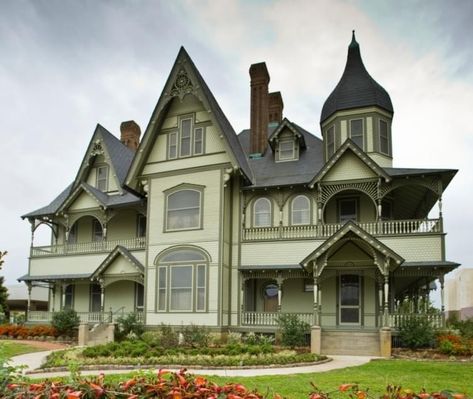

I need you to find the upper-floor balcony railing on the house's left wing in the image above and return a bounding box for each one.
[31,237,146,258]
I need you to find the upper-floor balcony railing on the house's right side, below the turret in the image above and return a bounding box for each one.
[243,219,442,241]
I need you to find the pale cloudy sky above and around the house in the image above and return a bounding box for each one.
[0,0,473,304]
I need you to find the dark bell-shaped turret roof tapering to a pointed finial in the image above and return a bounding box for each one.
[320,31,394,123]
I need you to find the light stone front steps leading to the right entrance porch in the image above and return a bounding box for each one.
[320,329,381,356]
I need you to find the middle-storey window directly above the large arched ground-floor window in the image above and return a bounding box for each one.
[166,189,202,230]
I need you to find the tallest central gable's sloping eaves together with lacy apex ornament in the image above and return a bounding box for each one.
[125,47,252,191]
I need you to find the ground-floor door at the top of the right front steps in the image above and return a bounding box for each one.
[338,274,361,325]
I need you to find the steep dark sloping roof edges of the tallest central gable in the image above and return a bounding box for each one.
[126,47,253,190]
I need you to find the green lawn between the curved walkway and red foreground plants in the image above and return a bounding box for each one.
[94,360,473,399]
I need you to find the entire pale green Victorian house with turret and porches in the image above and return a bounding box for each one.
[20,35,458,355]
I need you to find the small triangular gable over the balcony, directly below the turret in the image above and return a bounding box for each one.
[311,139,391,186]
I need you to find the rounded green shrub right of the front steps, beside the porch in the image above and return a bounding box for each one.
[399,317,436,349]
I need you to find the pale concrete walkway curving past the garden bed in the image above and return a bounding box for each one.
[11,351,375,378]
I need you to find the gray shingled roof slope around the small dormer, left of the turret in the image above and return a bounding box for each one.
[238,122,324,188]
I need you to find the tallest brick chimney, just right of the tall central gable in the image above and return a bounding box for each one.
[250,62,269,154]
